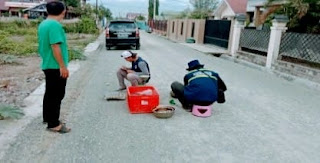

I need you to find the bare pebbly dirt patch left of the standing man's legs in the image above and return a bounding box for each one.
[0,54,44,107]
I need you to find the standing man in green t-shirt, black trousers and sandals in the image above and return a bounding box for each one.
[38,1,71,133]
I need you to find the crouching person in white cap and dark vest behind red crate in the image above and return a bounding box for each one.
[117,51,150,91]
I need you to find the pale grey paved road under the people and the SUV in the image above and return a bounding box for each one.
[0,33,320,163]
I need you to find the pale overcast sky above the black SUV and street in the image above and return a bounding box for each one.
[87,0,191,17]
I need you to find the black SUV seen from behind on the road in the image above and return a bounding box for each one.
[106,20,140,50]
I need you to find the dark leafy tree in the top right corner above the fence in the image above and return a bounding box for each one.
[267,0,320,34]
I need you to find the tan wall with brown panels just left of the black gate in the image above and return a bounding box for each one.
[167,19,205,44]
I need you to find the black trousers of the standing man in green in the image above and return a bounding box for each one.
[43,69,67,128]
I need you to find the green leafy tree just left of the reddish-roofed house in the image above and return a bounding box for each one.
[189,0,219,19]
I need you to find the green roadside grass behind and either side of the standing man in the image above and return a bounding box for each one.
[0,18,99,64]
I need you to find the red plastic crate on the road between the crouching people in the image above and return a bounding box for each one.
[127,86,159,113]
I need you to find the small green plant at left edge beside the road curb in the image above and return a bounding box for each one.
[0,104,24,119]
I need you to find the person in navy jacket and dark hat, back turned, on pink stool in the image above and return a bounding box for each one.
[170,60,227,111]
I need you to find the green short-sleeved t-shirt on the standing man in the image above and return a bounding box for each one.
[38,19,69,70]
